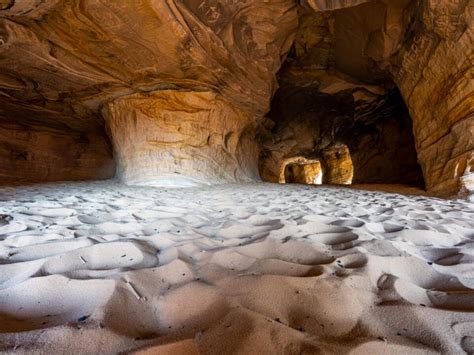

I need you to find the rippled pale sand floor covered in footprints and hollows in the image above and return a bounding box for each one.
[0,182,474,354]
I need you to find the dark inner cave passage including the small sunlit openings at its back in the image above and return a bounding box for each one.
[259,79,424,188]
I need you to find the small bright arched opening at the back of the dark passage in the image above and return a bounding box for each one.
[279,157,323,185]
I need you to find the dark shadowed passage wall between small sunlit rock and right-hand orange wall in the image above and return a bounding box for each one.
[346,90,424,187]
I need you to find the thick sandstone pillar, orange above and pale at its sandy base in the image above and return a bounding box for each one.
[102,90,259,186]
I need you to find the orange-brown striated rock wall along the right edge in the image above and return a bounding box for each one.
[392,0,474,196]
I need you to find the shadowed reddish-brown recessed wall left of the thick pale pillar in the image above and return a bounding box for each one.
[0,124,115,184]
